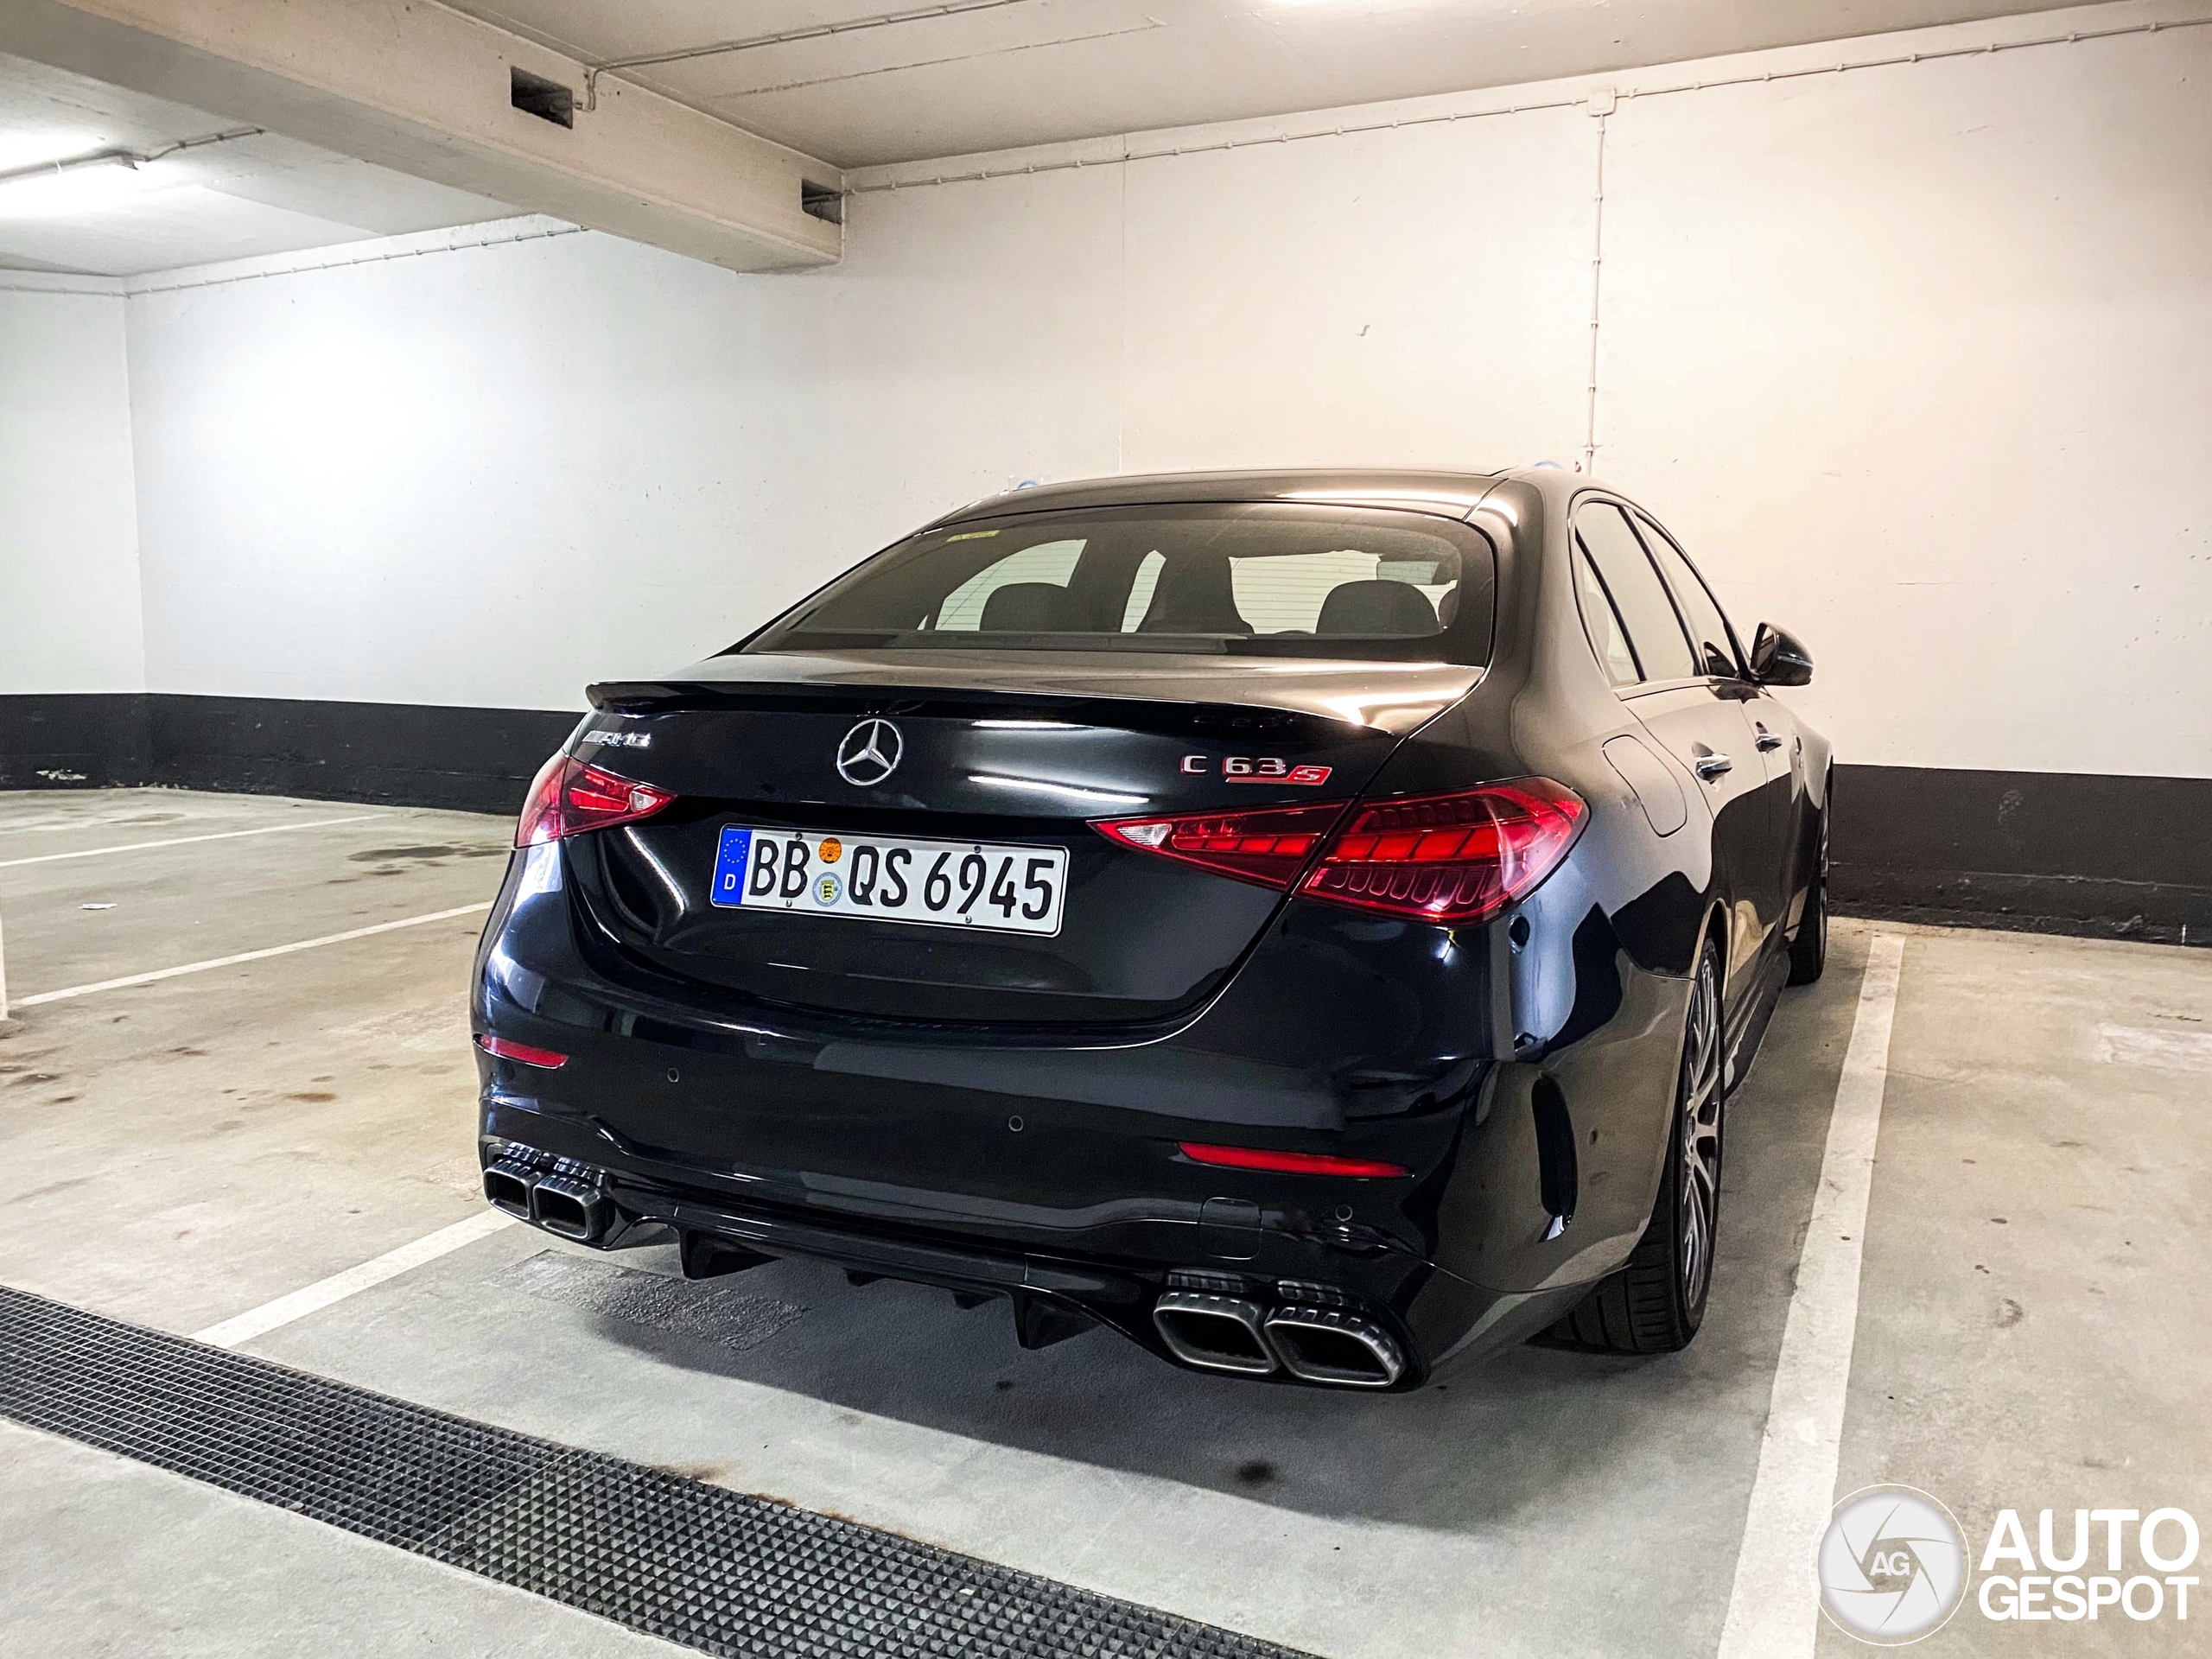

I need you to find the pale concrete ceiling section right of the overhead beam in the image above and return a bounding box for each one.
[449,0,2114,168]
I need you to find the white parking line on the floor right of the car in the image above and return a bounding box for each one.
[1719,933,1904,1659]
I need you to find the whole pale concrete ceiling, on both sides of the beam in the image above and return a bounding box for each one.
[0,0,2123,276]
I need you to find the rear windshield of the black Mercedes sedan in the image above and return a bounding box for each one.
[743,502,1496,664]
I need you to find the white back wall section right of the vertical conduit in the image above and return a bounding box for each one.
[1599,24,2212,777]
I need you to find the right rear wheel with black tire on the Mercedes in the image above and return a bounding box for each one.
[1540,940,1727,1354]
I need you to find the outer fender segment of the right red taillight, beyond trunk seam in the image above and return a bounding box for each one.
[1300,779,1588,925]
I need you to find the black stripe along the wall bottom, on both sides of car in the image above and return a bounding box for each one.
[0,692,2212,944]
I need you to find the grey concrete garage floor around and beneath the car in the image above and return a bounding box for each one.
[0,791,2212,1659]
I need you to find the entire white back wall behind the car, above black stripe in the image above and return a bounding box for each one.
[104,0,2212,774]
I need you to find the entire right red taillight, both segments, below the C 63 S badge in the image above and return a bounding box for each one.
[1090,779,1588,925]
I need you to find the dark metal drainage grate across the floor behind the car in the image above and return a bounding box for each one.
[0,1287,1287,1659]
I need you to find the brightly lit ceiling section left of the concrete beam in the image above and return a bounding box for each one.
[0,55,513,276]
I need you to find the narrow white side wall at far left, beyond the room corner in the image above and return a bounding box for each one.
[0,279,146,695]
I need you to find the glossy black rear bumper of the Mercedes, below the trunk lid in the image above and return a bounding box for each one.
[474,847,1672,1389]
